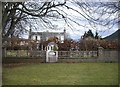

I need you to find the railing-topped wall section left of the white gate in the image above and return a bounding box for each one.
[2,50,46,64]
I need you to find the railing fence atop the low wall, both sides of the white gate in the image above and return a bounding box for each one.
[4,50,98,58]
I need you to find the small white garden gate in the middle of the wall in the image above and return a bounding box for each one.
[46,50,58,62]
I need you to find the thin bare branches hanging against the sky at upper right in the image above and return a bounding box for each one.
[75,1,120,28]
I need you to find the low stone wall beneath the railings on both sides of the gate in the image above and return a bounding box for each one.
[2,50,118,63]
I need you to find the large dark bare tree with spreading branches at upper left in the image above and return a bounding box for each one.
[2,0,66,38]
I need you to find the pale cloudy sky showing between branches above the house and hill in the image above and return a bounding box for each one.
[21,0,118,39]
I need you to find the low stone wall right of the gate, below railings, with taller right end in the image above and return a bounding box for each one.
[58,50,118,62]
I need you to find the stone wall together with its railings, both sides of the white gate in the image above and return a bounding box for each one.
[3,50,118,62]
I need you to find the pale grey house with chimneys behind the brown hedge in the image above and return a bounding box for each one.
[29,29,67,43]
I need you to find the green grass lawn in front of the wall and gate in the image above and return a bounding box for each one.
[3,63,118,85]
